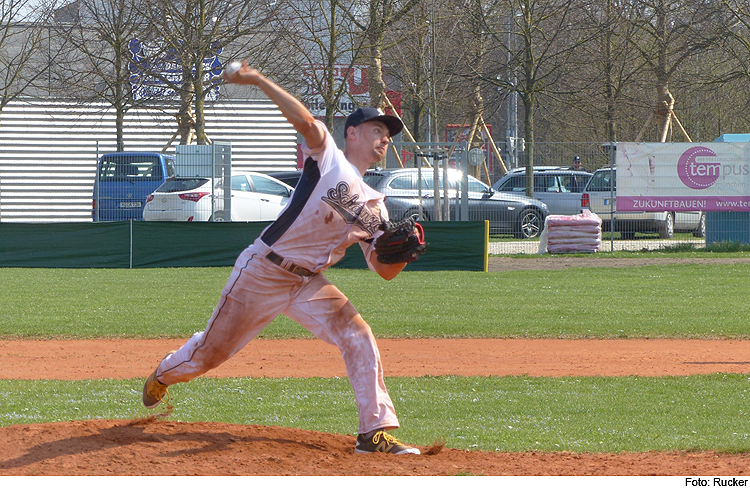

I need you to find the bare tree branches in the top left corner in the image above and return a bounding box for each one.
[0,0,54,123]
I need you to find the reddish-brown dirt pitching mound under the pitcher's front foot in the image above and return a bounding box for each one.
[0,416,750,476]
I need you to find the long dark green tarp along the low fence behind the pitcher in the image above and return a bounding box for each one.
[0,221,485,271]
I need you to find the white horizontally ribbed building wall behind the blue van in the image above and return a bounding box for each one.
[0,98,297,222]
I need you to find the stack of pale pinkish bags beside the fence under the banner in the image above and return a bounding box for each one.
[539,210,602,254]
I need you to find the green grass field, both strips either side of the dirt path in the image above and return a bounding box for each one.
[0,259,750,452]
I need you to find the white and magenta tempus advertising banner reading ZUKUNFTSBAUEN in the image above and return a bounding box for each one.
[616,142,750,212]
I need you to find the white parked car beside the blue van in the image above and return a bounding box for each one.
[143,172,294,222]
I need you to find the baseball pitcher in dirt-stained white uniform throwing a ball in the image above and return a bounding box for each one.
[143,62,426,454]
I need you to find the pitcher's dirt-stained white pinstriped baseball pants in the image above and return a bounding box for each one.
[156,240,399,434]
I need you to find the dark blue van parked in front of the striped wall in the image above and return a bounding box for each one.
[91,152,175,222]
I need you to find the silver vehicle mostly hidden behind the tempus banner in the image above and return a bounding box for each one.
[581,167,706,240]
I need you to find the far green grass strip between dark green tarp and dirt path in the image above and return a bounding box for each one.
[0,259,750,339]
